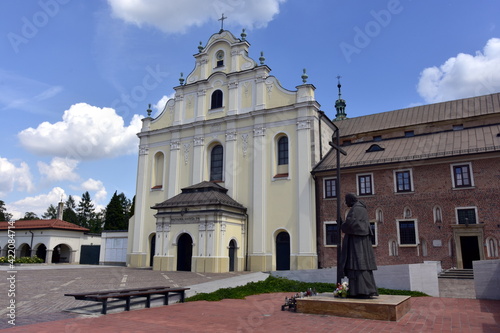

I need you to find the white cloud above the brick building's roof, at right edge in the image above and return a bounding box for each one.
[417,38,500,103]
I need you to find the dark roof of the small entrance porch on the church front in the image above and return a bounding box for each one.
[151,181,246,210]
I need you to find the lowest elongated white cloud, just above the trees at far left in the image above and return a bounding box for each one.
[5,187,66,220]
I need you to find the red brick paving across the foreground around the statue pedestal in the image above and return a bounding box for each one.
[2,293,500,333]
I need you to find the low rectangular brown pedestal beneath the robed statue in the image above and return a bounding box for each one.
[297,293,410,321]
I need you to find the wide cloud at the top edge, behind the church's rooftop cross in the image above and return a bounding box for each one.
[108,0,286,33]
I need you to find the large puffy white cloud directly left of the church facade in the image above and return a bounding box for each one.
[18,103,142,161]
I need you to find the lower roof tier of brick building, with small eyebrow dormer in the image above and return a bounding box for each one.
[313,124,500,173]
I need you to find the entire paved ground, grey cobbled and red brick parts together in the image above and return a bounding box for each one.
[0,267,500,333]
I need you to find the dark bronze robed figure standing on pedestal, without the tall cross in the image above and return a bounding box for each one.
[339,193,378,298]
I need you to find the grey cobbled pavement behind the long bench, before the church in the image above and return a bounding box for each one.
[0,265,249,329]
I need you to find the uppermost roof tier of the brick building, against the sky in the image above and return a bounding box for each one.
[335,93,500,137]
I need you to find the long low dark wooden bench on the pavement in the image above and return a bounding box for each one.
[64,287,189,314]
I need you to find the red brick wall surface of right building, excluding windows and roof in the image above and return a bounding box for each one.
[316,154,500,269]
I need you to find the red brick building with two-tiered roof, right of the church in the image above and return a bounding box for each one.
[312,91,500,268]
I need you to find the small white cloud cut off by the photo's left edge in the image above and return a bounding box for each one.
[0,157,33,195]
